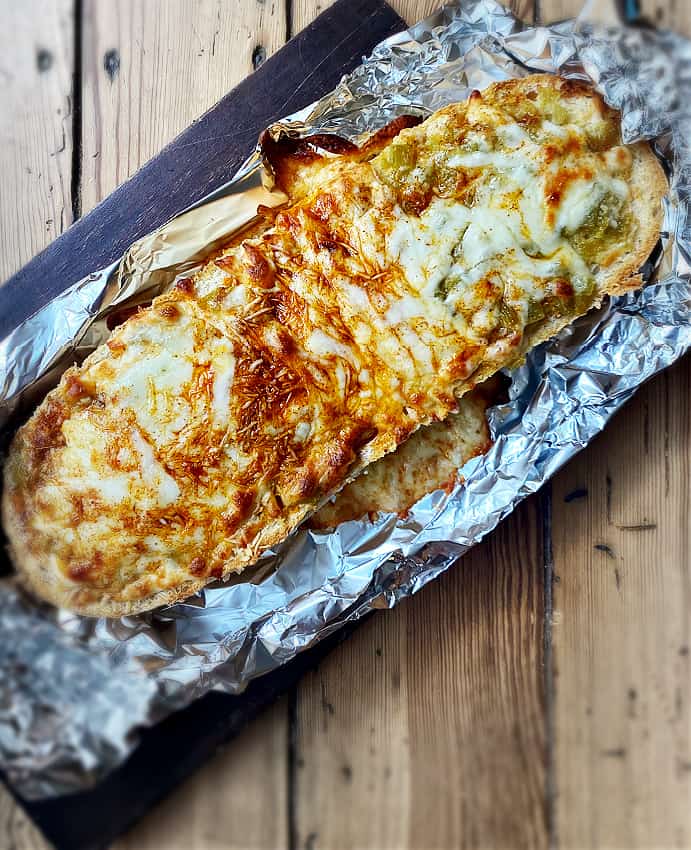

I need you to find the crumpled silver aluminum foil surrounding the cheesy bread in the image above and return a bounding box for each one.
[0,0,691,798]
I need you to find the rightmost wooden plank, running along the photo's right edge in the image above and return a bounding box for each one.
[542,0,691,849]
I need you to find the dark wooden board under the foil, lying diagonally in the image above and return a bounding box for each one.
[0,0,405,850]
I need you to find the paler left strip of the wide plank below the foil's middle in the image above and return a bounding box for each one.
[292,604,412,850]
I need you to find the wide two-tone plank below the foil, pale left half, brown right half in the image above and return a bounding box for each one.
[295,500,547,850]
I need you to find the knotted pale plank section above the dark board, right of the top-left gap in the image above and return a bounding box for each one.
[82,0,286,212]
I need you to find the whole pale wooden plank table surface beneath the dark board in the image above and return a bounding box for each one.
[0,0,691,850]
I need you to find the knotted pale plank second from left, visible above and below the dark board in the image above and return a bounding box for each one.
[73,0,288,850]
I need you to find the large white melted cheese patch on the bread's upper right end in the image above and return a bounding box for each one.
[387,116,628,322]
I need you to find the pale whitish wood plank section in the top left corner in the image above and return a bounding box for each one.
[0,0,73,281]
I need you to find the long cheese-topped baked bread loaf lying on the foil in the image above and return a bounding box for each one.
[3,76,665,615]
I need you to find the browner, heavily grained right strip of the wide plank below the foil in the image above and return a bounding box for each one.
[407,498,548,850]
